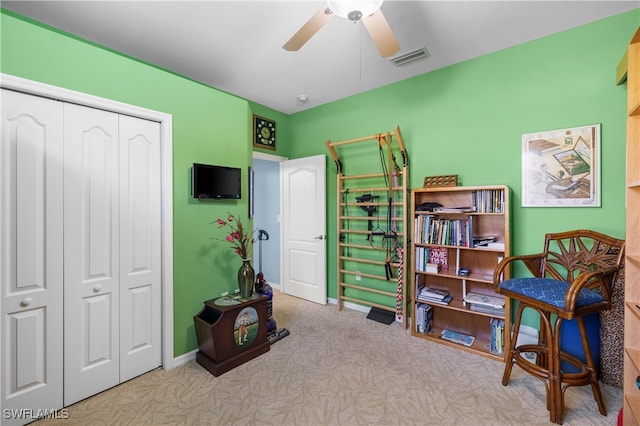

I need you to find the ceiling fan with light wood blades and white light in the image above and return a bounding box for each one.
[282,0,400,58]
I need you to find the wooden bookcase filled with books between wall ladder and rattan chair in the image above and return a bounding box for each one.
[411,185,510,359]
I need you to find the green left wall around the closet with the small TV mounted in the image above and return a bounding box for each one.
[0,10,272,356]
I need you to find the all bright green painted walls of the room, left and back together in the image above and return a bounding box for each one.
[0,10,640,356]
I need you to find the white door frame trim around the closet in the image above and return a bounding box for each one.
[0,73,174,370]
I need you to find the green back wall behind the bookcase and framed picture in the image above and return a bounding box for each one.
[289,10,640,316]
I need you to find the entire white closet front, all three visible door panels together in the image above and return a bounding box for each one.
[0,90,162,412]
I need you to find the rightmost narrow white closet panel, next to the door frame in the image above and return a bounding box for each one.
[120,115,162,382]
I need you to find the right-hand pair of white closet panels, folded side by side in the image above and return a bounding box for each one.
[64,105,162,405]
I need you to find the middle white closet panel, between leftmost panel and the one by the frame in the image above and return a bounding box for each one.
[64,104,120,405]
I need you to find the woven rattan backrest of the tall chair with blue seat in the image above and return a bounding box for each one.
[541,230,625,293]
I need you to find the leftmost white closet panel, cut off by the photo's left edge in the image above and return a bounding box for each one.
[0,90,63,425]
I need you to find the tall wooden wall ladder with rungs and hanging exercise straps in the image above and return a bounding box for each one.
[326,127,411,329]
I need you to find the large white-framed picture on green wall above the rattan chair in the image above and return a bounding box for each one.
[522,124,600,207]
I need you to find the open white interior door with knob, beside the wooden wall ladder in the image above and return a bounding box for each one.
[280,155,327,305]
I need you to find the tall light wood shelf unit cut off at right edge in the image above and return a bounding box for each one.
[623,29,640,425]
